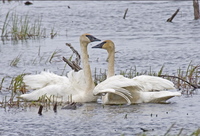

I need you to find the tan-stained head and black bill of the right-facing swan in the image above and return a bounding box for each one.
[80,33,101,44]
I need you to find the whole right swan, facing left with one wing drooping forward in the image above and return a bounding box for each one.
[92,40,181,104]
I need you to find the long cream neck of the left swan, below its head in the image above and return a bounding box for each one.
[80,41,95,91]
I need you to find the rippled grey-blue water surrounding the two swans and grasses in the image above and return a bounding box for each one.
[0,1,200,136]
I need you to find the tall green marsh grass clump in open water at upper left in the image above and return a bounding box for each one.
[1,11,46,41]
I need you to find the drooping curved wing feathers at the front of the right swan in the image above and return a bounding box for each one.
[94,89,131,105]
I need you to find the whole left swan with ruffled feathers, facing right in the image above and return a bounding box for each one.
[19,33,100,102]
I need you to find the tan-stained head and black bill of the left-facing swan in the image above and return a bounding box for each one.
[92,40,115,52]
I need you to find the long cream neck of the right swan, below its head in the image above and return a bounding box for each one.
[107,50,115,78]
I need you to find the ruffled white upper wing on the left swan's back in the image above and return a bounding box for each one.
[23,71,67,89]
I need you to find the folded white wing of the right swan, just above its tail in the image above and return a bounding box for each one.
[133,75,176,92]
